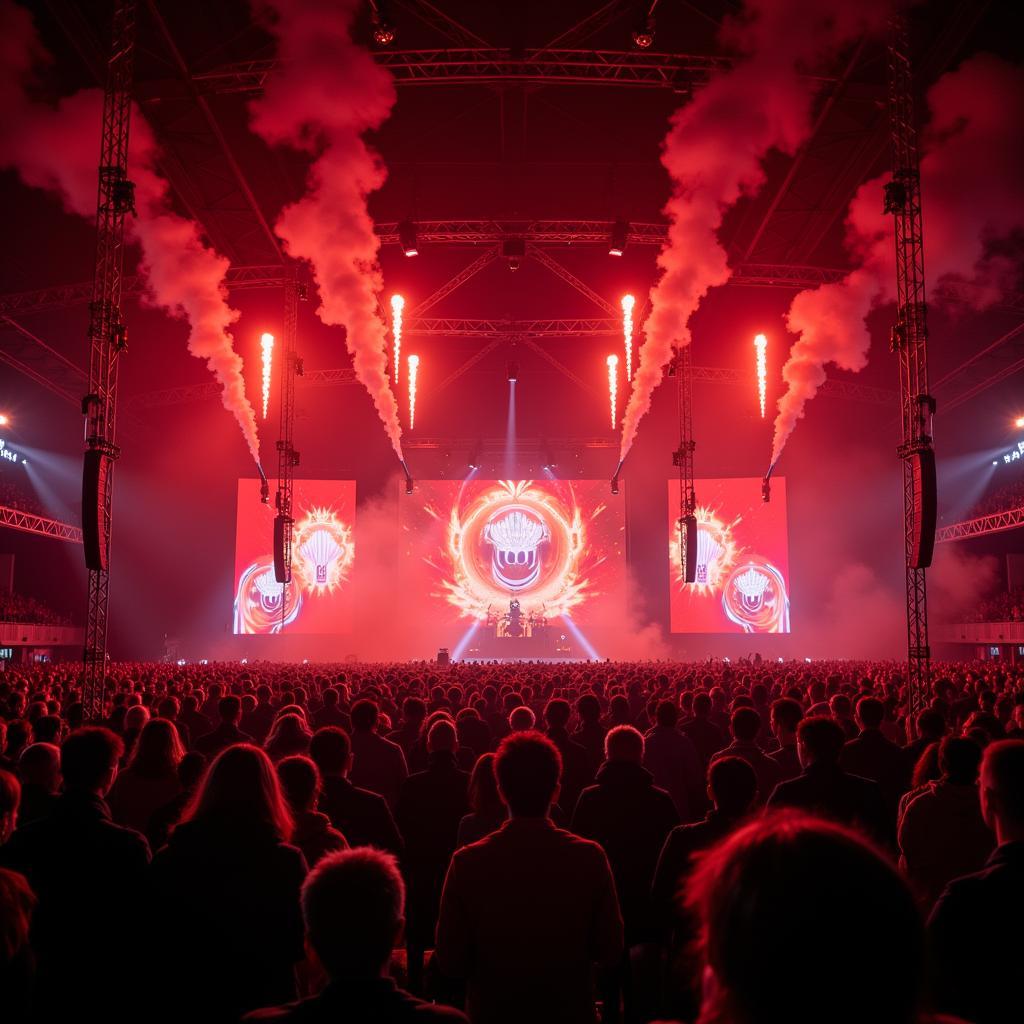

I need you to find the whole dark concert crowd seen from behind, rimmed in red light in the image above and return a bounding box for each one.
[0,662,1024,1024]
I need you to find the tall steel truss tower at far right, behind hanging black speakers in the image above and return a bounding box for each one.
[885,16,935,721]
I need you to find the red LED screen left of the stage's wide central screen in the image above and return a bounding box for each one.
[234,479,355,634]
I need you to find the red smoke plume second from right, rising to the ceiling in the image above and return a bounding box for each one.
[621,0,889,459]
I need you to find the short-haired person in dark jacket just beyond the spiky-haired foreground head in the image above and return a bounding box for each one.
[309,725,402,854]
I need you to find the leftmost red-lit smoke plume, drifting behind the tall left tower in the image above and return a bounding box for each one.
[0,0,259,462]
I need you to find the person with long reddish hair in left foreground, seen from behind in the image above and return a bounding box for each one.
[147,744,306,1022]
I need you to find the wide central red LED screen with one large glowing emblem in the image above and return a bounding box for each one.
[399,478,626,644]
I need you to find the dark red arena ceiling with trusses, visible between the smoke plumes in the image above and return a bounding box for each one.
[0,0,1024,440]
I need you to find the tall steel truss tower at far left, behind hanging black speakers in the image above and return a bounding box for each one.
[82,0,136,719]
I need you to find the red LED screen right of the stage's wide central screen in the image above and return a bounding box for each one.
[669,477,790,633]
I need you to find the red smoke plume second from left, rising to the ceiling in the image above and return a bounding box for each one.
[252,0,402,459]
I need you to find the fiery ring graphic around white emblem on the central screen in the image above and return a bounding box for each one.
[434,480,589,620]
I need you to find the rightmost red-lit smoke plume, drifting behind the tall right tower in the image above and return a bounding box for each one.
[772,54,1024,464]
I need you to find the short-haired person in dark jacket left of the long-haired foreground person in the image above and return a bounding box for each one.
[0,726,150,1020]
